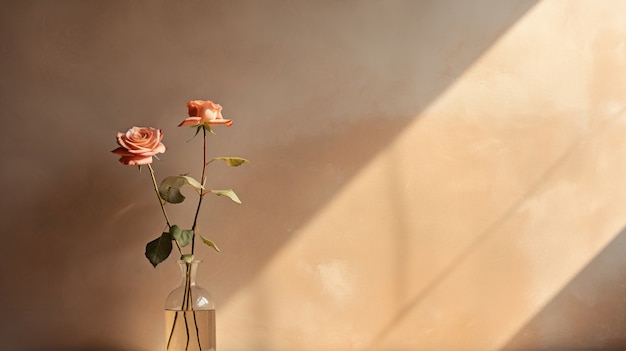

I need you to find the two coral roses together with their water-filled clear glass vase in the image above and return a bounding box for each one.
[112,100,248,351]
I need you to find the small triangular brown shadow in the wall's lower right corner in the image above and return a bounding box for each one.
[502,229,626,351]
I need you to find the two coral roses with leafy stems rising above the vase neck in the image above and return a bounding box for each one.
[112,100,248,267]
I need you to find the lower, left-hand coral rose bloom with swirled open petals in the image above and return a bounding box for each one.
[111,127,165,166]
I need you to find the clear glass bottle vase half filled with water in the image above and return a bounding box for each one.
[165,260,216,351]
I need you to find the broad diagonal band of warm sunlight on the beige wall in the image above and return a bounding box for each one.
[220,2,626,350]
